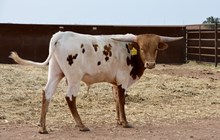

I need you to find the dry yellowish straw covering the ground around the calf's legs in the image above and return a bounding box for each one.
[0,63,220,128]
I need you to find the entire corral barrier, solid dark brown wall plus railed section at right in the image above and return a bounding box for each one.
[0,23,220,66]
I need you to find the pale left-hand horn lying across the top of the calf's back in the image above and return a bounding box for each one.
[111,34,137,42]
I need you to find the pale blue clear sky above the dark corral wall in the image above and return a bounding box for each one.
[0,0,220,25]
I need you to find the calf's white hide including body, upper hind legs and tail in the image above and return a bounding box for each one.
[11,32,138,100]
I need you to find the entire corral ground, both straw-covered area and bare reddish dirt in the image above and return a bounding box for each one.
[0,62,220,140]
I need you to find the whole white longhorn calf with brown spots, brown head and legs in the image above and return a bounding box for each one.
[10,32,182,134]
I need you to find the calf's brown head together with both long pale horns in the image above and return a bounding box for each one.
[112,34,183,69]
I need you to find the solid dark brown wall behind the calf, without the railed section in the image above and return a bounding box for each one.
[0,23,186,64]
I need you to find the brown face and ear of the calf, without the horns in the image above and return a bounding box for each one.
[137,34,168,69]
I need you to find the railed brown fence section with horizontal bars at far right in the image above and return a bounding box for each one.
[186,24,220,66]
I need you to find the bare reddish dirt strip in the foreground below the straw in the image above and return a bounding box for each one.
[0,119,220,140]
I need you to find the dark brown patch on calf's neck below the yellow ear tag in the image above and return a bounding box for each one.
[130,44,145,80]
